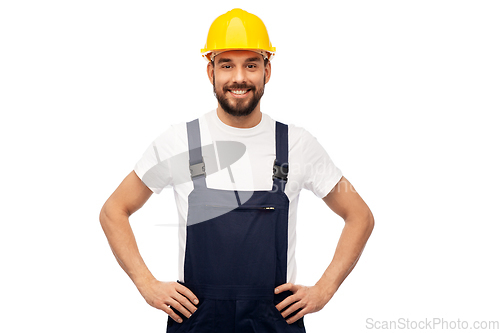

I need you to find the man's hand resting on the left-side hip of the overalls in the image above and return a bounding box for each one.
[138,280,198,323]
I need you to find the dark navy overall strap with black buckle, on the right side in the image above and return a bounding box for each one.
[273,121,288,192]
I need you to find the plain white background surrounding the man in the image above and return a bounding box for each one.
[0,0,500,333]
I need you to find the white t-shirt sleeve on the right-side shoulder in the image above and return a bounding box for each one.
[300,129,342,198]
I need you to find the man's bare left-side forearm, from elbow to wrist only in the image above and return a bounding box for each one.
[99,207,154,288]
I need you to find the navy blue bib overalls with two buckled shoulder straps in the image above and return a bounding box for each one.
[167,119,305,333]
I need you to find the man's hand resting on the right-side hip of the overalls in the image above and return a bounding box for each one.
[274,283,330,324]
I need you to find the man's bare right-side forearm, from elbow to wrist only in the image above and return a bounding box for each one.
[316,212,374,299]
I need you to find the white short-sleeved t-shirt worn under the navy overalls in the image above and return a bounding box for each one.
[134,110,342,283]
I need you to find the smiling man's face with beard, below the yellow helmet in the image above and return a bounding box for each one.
[207,51,271,117]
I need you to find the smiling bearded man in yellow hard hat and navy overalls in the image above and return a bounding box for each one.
[100,9,374,333]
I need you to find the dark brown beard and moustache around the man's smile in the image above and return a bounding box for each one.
[213,75,266,117]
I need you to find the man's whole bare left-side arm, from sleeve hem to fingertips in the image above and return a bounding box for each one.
[99,171,198,321]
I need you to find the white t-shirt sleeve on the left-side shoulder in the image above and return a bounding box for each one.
[134,126,176,194]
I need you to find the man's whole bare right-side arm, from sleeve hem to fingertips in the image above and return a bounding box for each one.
[276,177,375,323]
